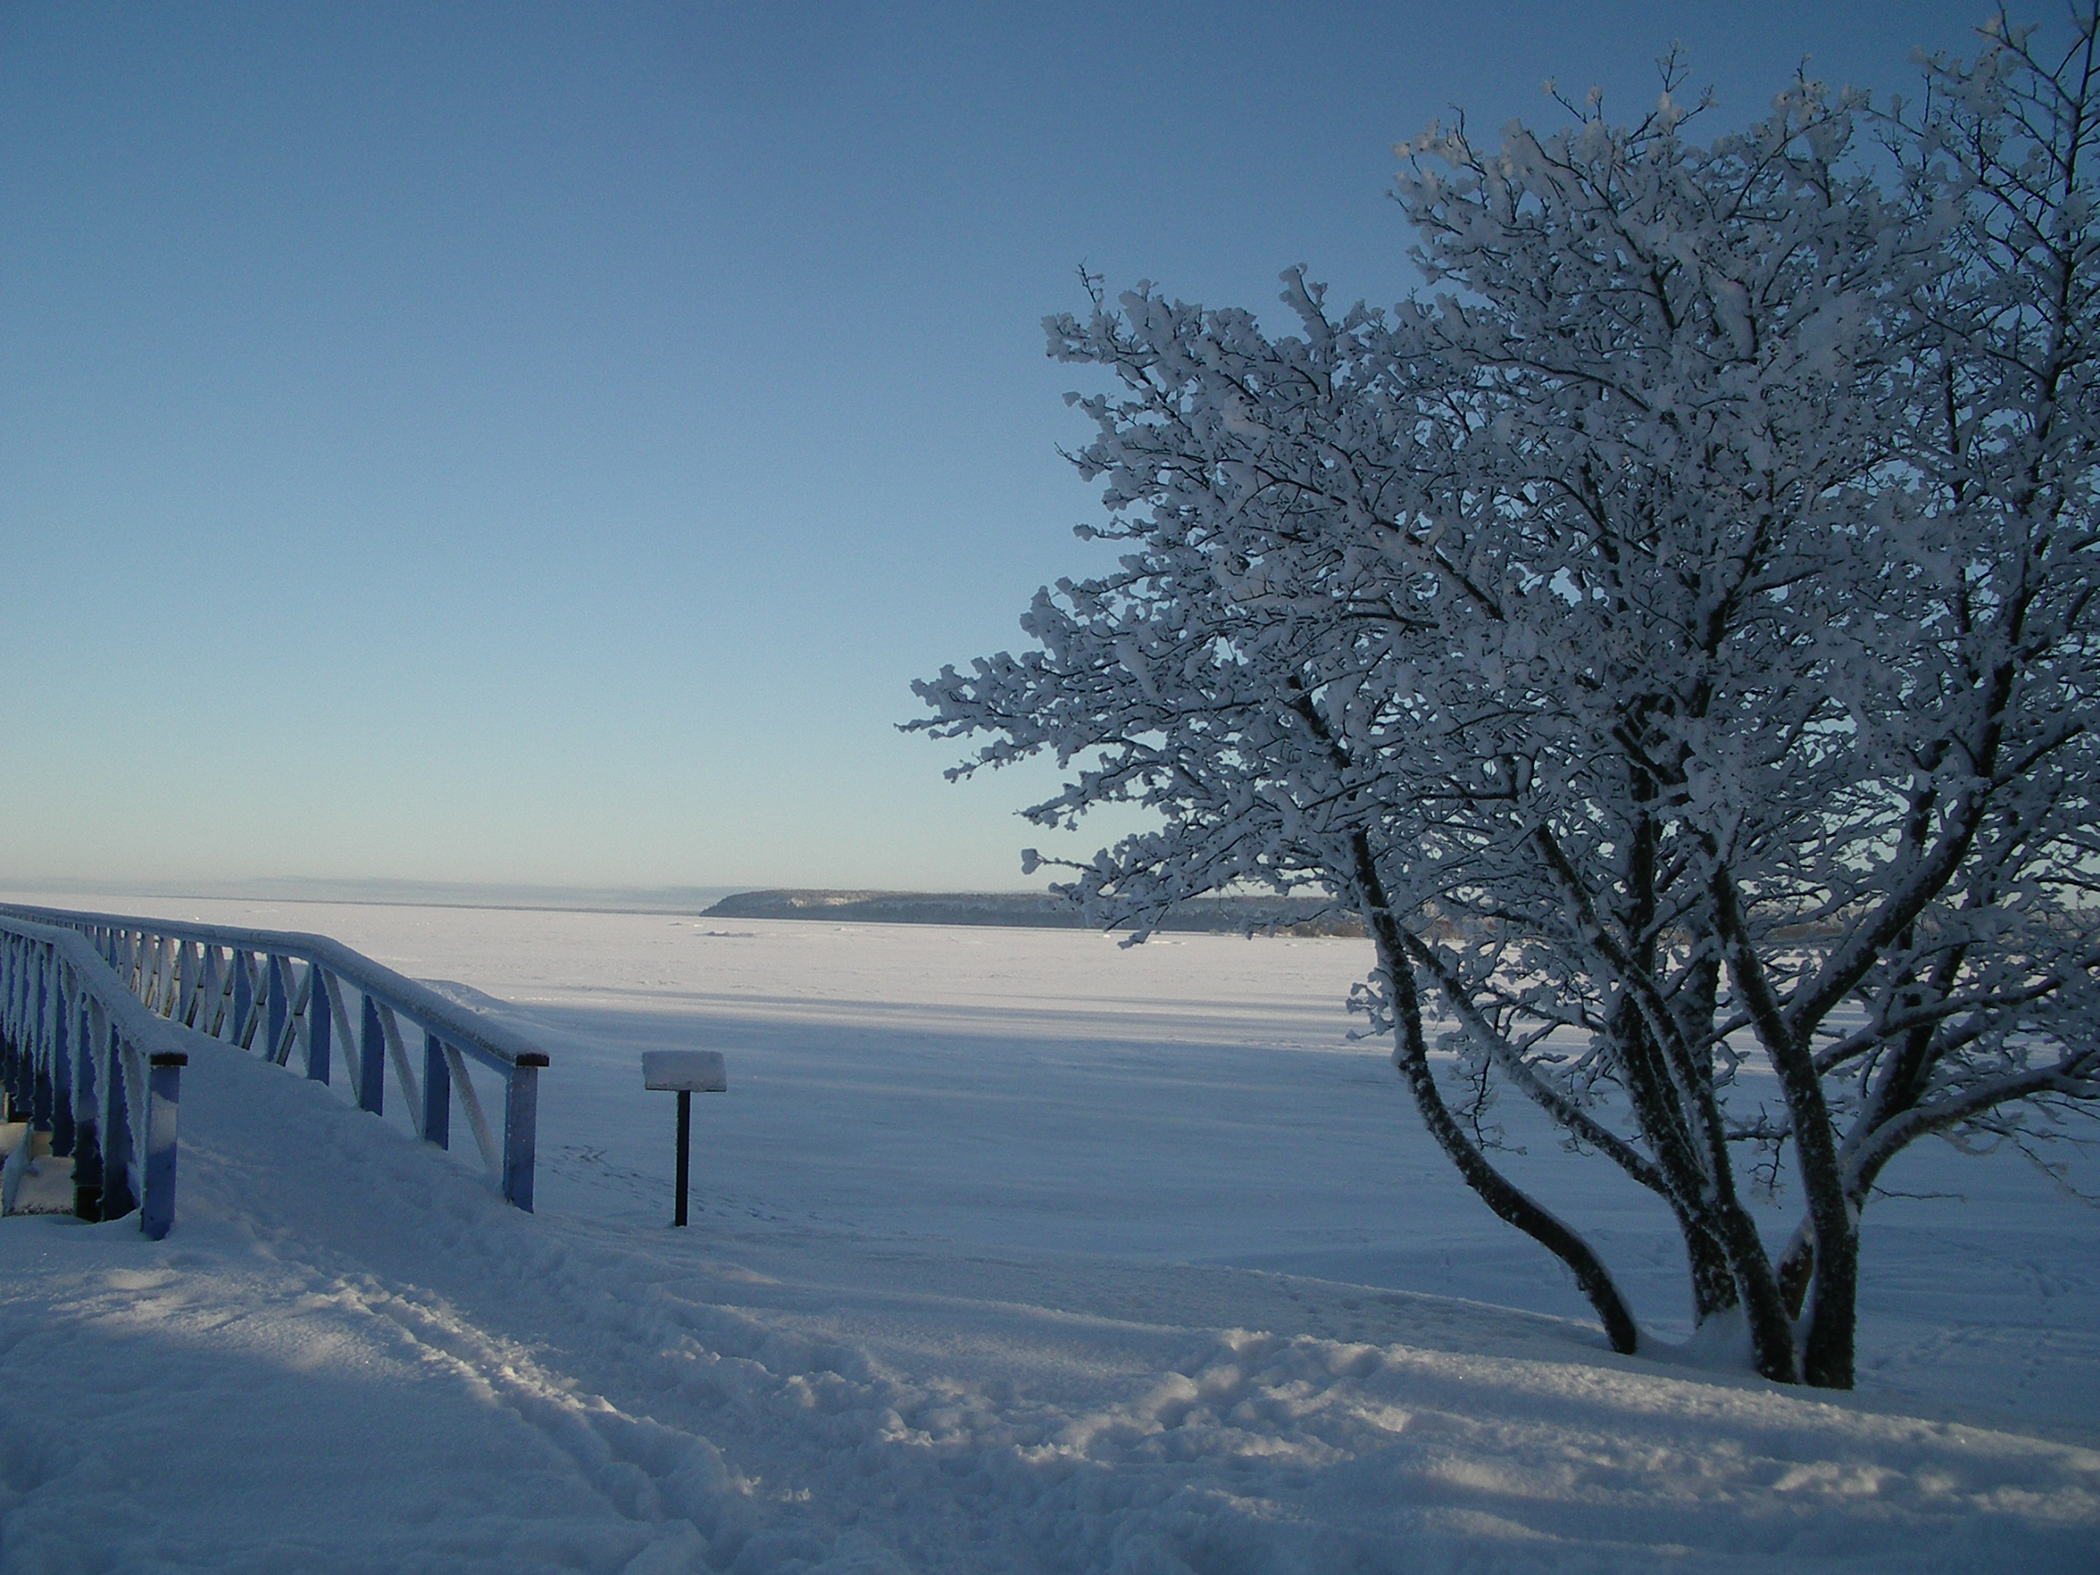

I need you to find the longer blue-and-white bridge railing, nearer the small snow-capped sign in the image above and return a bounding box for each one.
[0,907,548,1212]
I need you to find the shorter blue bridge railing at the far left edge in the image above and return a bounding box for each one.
[0,909,189,1241]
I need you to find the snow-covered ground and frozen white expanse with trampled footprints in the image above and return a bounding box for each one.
[0,893,2100,1575]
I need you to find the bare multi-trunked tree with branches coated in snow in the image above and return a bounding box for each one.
[911,8,2100,1386]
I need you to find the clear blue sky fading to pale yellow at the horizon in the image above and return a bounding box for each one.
[0,0,2024,888]
